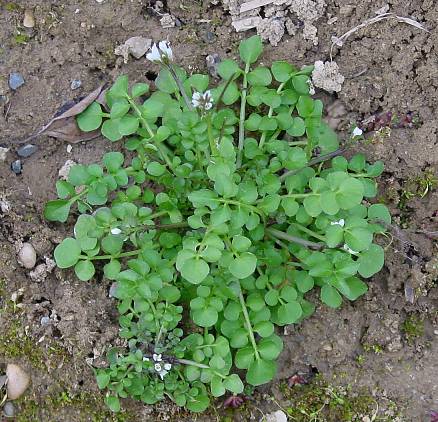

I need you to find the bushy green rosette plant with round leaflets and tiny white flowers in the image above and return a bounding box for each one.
[45,36,390,411]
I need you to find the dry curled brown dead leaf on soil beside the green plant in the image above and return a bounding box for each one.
[18,85,106,144]
